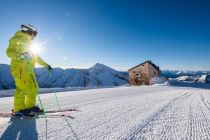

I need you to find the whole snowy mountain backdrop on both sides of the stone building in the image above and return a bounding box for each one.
[0,63,210,90]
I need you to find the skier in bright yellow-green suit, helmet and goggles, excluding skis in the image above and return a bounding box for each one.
[6,24,53,116]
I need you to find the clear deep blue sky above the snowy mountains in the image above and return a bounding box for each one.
[0,0,210,70]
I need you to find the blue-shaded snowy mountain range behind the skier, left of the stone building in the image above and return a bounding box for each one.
[0,63,128,89]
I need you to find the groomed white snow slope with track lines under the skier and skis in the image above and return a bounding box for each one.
[0,86,210,140]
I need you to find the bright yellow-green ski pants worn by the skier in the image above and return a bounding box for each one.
[11,66,39,112]
